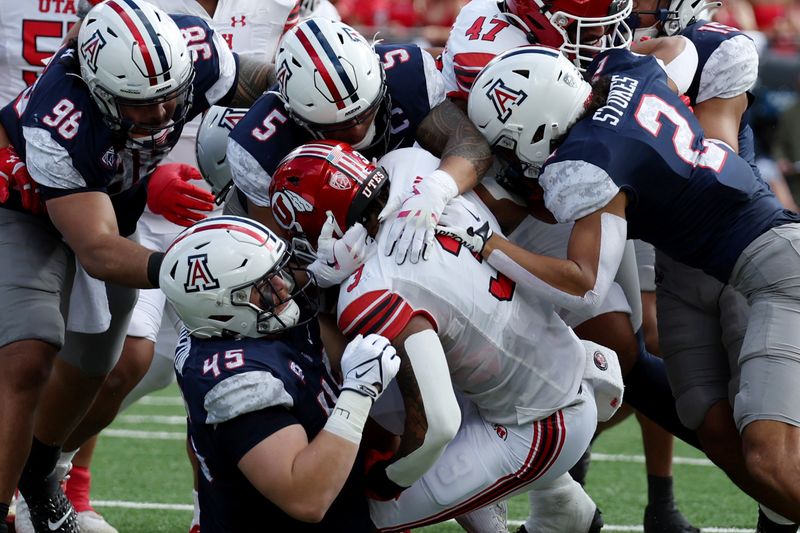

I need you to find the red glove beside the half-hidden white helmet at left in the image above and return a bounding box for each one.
[147,163,214,226]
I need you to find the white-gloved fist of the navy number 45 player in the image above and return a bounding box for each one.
[341,333,400,402]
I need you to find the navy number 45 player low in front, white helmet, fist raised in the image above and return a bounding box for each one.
[160,216,400,533]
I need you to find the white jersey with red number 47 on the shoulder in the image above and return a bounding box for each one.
[442,0,530,100]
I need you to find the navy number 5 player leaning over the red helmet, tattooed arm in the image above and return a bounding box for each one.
[226,18,492,270]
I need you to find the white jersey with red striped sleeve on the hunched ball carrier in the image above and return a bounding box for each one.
[338,148,586,424]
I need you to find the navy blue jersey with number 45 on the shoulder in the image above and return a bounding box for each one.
[175,321,372,533]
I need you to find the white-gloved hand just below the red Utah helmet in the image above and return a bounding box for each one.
[308,214,377,288]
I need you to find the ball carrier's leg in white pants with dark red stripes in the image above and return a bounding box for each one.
[370,387,597,533]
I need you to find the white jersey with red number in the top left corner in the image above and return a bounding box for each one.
[0,0,83,105]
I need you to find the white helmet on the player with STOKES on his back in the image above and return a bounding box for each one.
[467,46,592,178]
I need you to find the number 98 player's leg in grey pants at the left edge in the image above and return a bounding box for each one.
[0,209,75,525]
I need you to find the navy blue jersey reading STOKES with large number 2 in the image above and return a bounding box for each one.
[540,50,800,282]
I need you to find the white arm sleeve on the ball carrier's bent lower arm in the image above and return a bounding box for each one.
[386,329,461,487]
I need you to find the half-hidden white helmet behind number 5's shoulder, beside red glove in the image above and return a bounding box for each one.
[194,105,247,205]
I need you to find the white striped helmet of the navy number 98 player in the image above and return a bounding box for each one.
[78,0,194,136]
